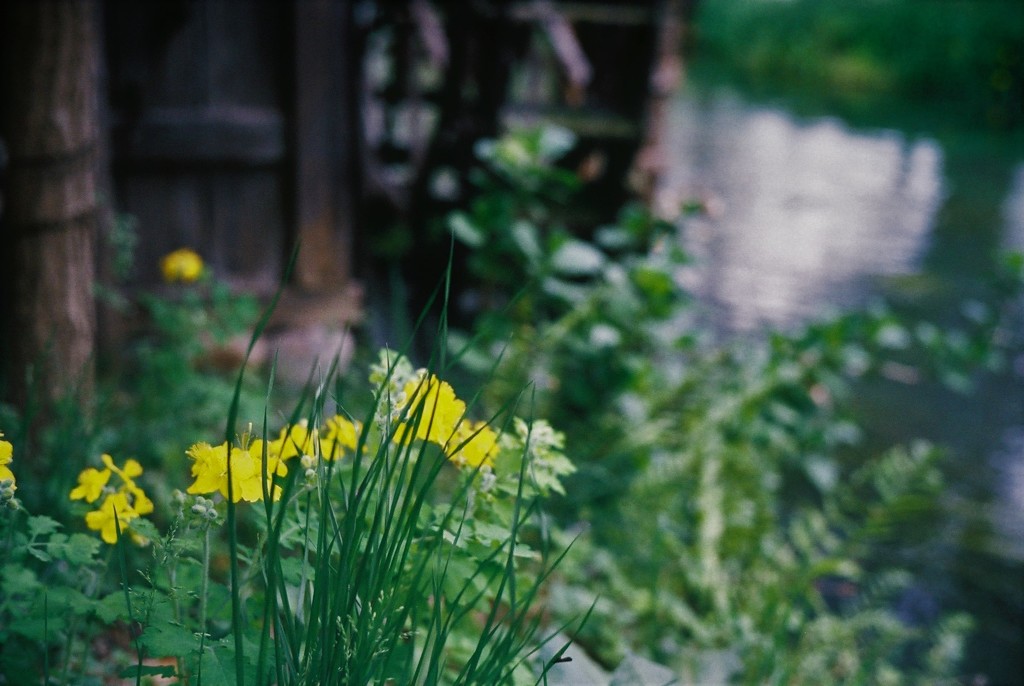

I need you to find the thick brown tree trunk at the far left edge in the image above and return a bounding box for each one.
[0,0,99,409]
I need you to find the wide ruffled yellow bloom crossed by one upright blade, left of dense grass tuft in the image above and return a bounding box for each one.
[186,439,288,503]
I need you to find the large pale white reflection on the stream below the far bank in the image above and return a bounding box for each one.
[660,93,943,330]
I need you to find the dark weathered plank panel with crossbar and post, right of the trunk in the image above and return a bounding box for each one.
[106,0,360,292]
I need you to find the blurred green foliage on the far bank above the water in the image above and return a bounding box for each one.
[696,0,1024,129]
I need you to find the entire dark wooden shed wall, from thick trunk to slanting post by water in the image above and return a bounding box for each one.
[105,0,679,301]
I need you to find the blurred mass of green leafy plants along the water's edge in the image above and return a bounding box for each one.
[444,123,1021,684]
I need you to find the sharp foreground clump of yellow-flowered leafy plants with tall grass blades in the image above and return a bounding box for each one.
[0,341,572,684]
